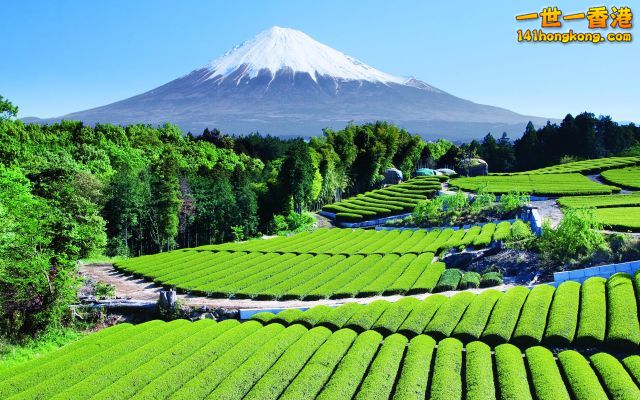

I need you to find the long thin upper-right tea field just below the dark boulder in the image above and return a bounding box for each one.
[449,173,620,196]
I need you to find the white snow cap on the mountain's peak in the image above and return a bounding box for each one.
[207,26,406,84]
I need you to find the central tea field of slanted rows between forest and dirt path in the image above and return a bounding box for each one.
[115,222,511,300]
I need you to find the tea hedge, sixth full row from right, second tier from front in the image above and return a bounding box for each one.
[453,289,502,343]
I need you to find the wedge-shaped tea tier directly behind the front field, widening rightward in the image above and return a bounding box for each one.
[252,274,640,350]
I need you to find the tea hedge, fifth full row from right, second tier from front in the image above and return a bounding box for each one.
[482,286,529,345]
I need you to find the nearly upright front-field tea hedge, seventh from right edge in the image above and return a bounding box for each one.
[430,338,462,400]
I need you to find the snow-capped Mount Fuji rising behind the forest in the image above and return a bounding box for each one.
[25,27,546,140]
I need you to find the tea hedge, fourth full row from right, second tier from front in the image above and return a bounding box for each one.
[512,285,555,347]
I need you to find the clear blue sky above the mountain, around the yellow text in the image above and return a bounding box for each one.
[0,0,640,121]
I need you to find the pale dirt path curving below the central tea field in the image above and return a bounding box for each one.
[80,264,514,309]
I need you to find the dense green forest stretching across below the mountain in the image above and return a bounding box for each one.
[0,93,640,338]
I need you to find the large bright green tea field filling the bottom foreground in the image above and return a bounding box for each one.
[0,320,640,400]
